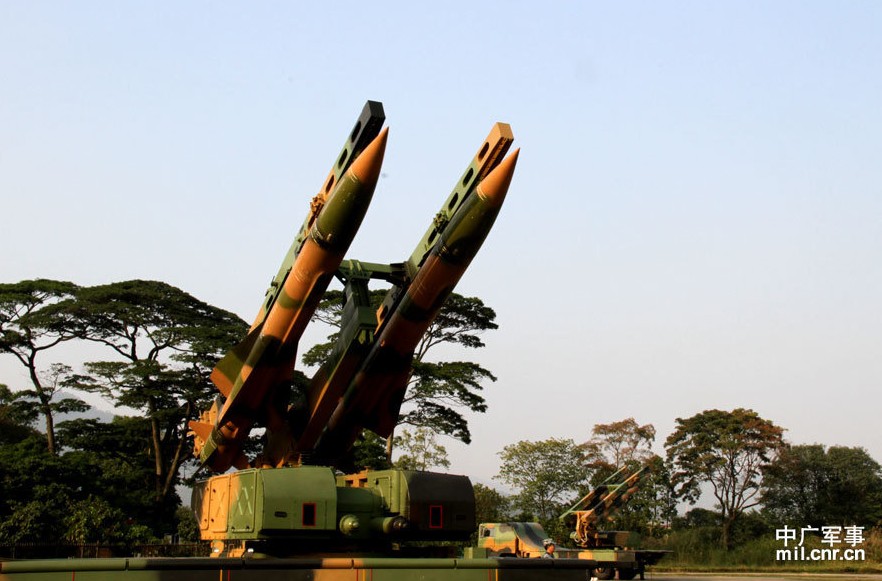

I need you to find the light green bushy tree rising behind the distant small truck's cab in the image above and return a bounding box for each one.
[494,438,588,526]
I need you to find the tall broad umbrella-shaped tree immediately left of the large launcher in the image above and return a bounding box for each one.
[55,280,247,505]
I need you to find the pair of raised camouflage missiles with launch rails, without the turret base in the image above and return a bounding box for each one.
[190,109,518,471]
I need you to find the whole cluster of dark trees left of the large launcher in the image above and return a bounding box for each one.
[0,279,247,542]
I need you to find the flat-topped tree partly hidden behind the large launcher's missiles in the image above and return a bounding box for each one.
[302,290,498,448]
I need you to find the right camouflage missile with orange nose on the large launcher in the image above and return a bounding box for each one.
[316,145,519,459]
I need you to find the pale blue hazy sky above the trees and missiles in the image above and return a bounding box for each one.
[0,0,882,485]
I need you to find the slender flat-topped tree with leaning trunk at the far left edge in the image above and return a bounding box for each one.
[0,279,86,454]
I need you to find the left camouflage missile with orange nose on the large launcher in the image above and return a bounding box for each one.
[190,122,388,471]
